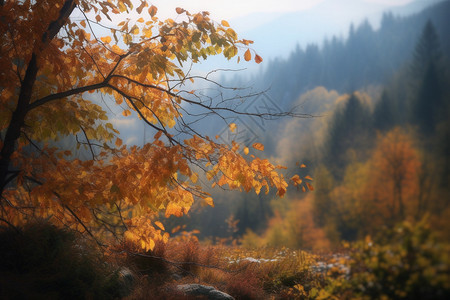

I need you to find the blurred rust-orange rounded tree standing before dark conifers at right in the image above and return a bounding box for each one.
[365,127,428,224]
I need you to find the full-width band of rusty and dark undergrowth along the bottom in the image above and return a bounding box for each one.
[0,222,450,299]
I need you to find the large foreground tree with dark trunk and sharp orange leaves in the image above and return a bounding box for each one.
[0,0,302,249]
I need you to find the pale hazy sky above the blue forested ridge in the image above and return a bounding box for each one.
[108,0,430,144]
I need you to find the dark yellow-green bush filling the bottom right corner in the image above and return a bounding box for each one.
[311,219,450,300]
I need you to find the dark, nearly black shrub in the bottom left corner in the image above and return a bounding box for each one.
[0,221,124,299]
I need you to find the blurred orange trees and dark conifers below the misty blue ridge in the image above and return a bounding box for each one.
[244,21,450,249]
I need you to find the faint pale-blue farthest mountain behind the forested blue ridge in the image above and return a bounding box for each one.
[236,0,440,58]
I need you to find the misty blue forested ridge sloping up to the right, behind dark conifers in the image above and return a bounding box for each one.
[227,1,450,109]
